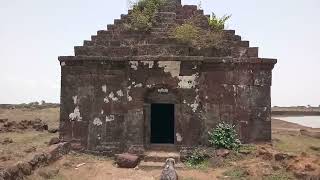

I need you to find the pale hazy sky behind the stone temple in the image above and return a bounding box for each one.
[0,0,320,106]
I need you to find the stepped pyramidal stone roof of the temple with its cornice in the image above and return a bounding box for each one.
[59,0,276,64]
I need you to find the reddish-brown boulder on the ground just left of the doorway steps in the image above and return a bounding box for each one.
[116,153,139,168]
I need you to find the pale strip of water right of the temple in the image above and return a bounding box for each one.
[273,116,320,128]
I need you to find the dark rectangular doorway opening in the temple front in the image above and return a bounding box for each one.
[150,104,174,144]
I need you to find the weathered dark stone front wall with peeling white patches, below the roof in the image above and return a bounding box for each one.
[61,57,271,153]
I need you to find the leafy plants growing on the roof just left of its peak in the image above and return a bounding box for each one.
[127,0,166,31]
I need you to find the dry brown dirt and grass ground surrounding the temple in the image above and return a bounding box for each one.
[0,108,320,180]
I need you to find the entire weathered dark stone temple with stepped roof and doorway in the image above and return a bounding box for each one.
[59,0,277,154]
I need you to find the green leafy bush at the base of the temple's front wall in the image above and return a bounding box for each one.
[208,122,241,150]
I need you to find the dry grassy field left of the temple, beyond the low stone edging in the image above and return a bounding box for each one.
[0,108,59,167]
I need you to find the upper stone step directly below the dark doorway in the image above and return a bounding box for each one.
[144,151,180,163]
